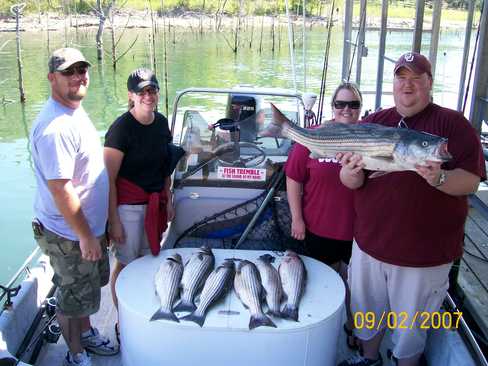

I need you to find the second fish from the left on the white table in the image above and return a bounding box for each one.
[174,246,215,312]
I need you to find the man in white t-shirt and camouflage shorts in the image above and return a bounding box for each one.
[30,48,118,366]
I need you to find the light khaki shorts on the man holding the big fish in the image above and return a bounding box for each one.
[348,242,452,359]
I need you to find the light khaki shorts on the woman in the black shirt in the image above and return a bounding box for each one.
[112,205,151,265]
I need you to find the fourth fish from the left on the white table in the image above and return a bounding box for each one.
[234,260,276,329]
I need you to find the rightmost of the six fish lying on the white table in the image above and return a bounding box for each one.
[278,250,307,321]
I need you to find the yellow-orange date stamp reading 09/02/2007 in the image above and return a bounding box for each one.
[353,311,463,330]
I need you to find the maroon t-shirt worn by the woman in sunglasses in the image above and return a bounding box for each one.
[285,144,354,240]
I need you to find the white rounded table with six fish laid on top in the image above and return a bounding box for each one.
[116,248,345,366]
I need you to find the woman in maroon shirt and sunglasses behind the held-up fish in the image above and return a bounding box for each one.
[286,83,362,348]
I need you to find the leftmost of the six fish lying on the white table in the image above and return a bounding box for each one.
[150,254,183,322]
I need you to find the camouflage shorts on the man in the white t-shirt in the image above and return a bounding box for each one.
[34,222,110,318]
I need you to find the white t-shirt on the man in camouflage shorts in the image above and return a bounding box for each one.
[30,98,109,240]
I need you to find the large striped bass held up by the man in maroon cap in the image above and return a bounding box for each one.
[259,104,452,172]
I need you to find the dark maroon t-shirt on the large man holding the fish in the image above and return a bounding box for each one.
[354,104,486,267]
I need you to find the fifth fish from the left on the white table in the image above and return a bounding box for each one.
[256,254,283,318]
